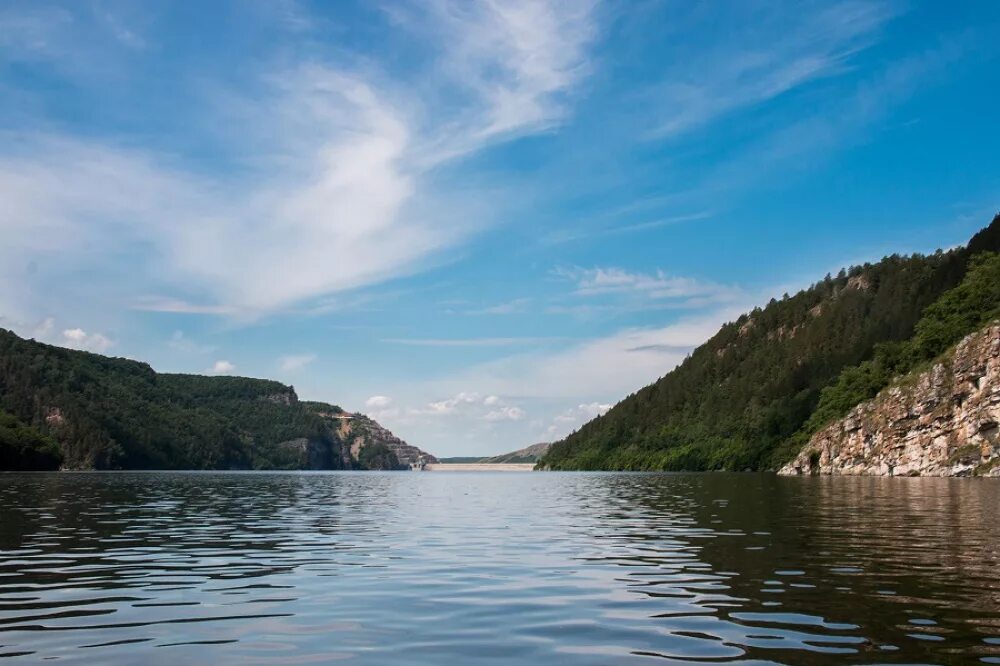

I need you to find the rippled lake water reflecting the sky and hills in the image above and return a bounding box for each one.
[0,472,1000,666]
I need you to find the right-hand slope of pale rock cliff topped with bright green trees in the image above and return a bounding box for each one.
[782,252,1000,476]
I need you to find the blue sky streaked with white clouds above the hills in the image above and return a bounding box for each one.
[0,0,1000,456]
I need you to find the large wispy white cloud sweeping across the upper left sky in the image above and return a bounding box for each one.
[0,1,595,317]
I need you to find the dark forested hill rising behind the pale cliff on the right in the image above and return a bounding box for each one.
[539,215,1000,470]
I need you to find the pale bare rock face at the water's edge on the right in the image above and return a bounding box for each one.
[778,323,1000,477]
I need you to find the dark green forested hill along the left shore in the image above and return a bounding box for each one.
[0,329,422,469]
